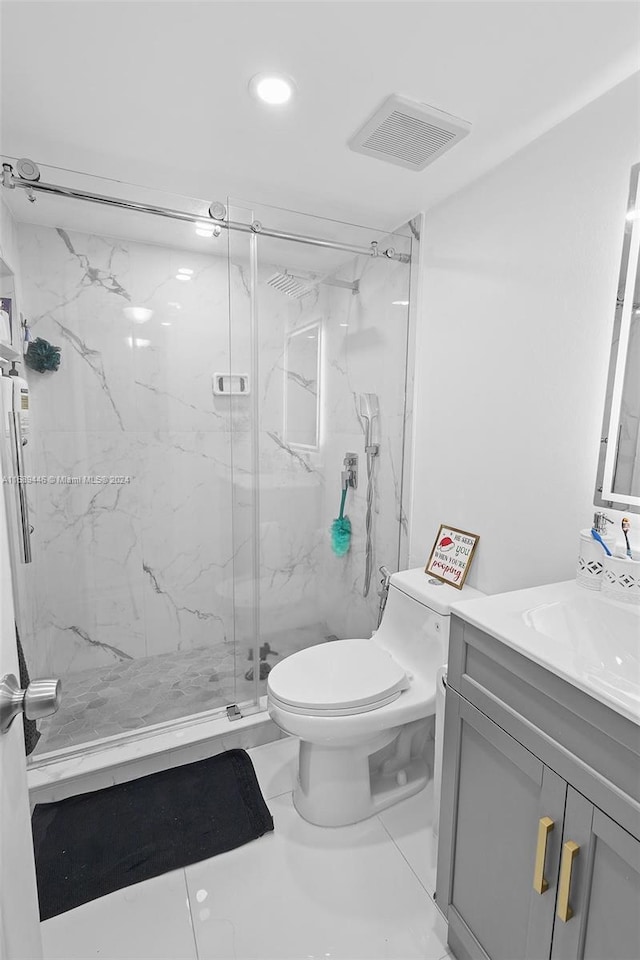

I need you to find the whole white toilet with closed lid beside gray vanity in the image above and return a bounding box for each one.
[267,567,482,827]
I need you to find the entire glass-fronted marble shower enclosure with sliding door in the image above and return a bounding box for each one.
[1,161,415,762]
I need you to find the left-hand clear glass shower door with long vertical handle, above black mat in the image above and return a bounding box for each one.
[3,169,248,761]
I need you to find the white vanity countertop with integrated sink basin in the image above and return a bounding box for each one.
[451,580,640,725]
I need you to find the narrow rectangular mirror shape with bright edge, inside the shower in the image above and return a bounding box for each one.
[284,321,322,449]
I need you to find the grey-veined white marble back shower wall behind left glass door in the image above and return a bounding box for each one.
[19,224,243,676]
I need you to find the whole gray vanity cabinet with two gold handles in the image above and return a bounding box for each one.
[436,618,640,960]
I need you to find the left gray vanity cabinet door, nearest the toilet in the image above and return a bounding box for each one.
[439,689,567,960]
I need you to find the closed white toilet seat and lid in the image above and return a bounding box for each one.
[268,640,409,717]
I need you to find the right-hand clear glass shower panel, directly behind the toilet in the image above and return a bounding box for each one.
[225,202,411,696]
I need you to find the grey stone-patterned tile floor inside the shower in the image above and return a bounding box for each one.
[34,624,335,756]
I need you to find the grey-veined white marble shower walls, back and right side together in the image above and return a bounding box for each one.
[19,224,409,688]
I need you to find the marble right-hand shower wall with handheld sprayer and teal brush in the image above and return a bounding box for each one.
[245,241,410,646]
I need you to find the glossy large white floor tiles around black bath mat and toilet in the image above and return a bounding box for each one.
[42,738,449,960]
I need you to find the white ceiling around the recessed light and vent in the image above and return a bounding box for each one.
[0,0,640,229]
